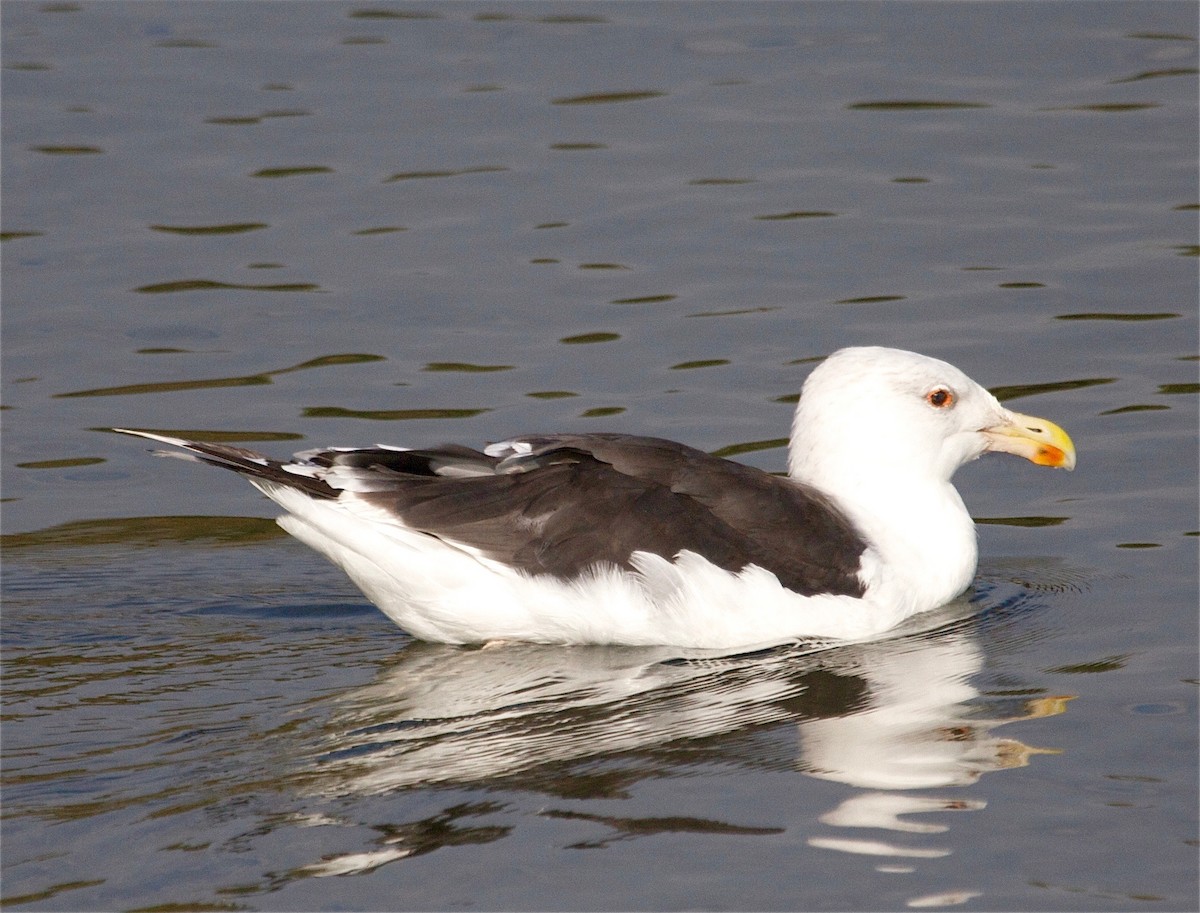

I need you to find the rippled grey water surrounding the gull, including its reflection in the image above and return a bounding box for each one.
[2,1,1200,911]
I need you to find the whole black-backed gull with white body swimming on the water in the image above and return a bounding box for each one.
[119,348,1075,649]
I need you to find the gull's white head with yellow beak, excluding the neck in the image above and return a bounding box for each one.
[788,347,1075,494]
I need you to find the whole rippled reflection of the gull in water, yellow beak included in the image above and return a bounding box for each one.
[300,602,1069,871]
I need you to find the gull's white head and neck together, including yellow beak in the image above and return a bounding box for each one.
[788,348,1075,620]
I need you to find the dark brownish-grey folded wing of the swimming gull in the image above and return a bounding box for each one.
[362,434,866,596]
